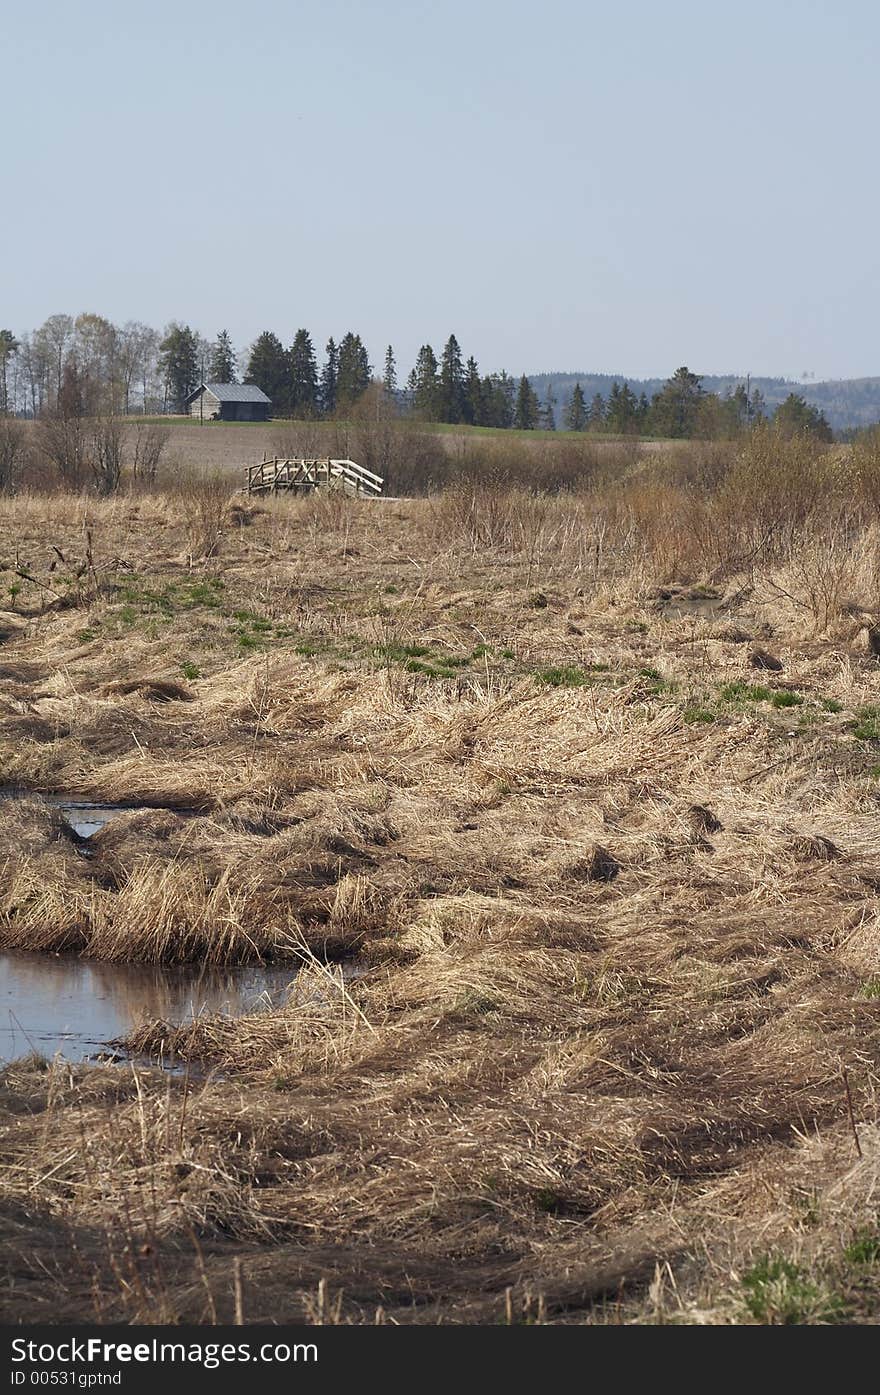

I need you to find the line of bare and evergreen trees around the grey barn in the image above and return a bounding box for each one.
[0,314,831,439]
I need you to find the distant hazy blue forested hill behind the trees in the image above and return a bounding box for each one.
[530,372,880,431]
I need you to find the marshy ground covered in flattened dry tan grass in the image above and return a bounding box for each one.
[0,463,880,1322]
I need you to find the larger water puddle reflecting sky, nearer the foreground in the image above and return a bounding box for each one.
[0,953,296,1062]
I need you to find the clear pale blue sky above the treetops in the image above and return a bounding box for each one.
[0,0,880,378]
